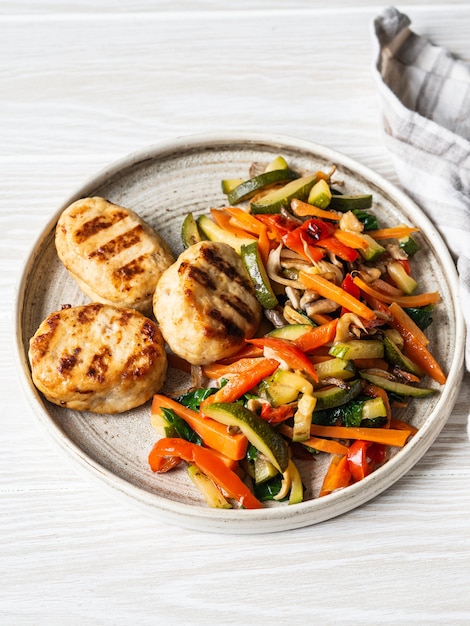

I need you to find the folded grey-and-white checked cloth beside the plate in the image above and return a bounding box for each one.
[373,7,470,370]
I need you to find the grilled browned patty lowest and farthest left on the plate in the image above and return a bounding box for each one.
[29,303,167,413]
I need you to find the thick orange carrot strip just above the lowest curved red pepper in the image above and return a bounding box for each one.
[152,394,248,461]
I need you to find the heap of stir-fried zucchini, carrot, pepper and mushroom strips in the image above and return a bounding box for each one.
[149,157,446,508]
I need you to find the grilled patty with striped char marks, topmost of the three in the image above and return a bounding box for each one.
[55,197,174,313]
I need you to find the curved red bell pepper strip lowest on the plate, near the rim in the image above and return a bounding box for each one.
[149,437,263,509]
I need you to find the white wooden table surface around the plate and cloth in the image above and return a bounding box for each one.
[0,0,470,626]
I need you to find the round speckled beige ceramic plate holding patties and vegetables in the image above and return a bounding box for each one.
[16,134,464,534]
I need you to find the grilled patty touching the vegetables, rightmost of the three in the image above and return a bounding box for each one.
[153,241,261,365]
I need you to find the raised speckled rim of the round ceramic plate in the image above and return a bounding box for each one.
[14,132,465,534]
